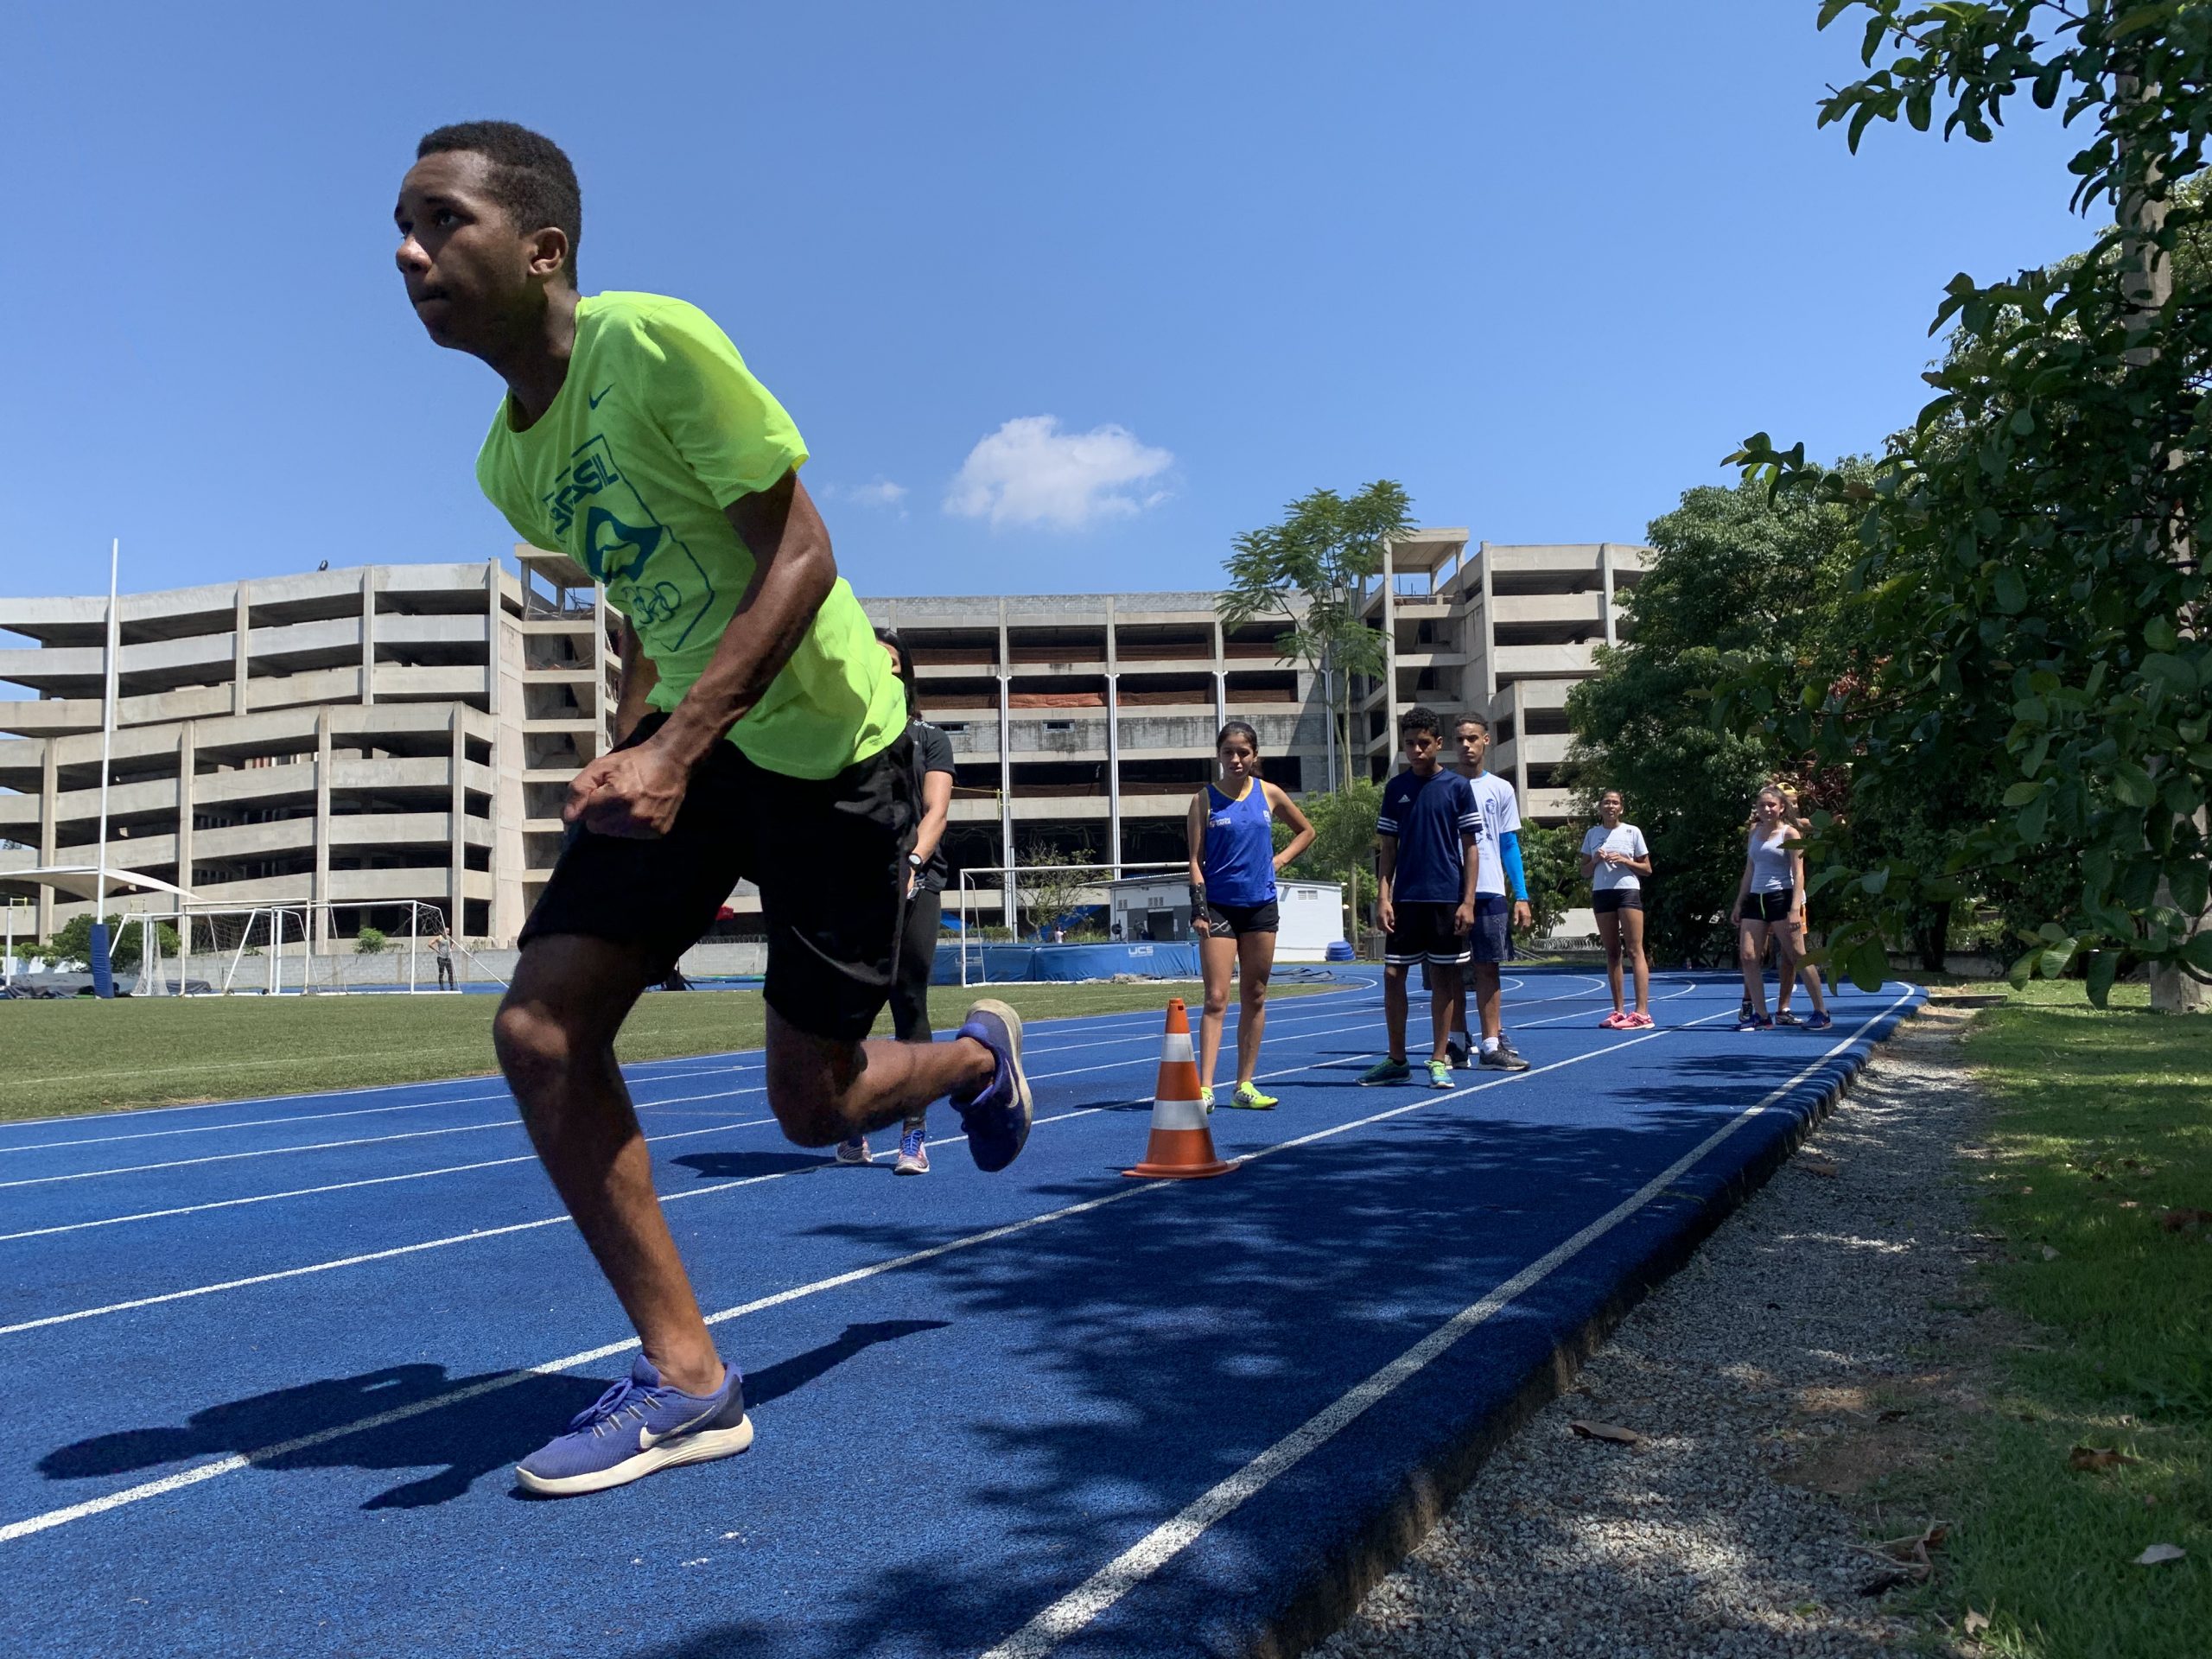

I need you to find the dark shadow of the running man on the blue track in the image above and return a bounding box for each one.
[38,1319,947,1509]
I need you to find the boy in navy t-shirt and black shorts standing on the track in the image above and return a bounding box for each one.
[1360,703,1482,1089]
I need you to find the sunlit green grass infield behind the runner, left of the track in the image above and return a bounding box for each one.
[0,982,1327,1119]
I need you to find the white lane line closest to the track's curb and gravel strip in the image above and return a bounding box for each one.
[982,991,1911,1659]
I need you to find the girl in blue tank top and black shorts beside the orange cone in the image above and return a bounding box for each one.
[1190,721,1314,1113]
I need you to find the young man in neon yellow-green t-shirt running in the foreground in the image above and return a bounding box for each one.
[394,122,1028,1493]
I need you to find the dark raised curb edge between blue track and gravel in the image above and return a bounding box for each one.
[1234,995,1927,1659]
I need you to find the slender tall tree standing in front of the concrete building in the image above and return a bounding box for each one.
[1217,478,1414,777]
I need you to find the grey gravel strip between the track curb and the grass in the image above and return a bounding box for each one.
[1314,1013,1980,1659]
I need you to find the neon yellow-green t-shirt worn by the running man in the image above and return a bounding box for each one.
[475,294,907,779]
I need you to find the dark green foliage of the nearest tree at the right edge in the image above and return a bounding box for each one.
[1717,0,2212,1000]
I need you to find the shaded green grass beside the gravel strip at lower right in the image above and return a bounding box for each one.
[1933,982,2212,1659]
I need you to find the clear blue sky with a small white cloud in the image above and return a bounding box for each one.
[0,0,2088,593]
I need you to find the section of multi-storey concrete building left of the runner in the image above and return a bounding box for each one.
[0,550,615,943]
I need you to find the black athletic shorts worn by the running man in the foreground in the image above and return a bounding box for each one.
[522,715,920,1042]
